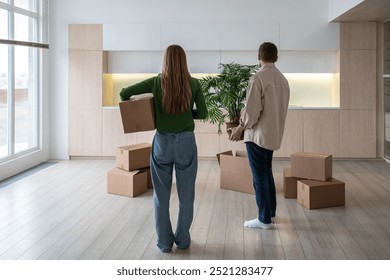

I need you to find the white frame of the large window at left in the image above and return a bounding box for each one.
[0,0,49,164]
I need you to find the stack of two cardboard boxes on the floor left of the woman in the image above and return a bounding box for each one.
[107,143,152,197]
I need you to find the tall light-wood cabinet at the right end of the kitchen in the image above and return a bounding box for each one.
[339,22,376,158]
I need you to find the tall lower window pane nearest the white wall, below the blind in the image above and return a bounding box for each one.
[14,46,38,153]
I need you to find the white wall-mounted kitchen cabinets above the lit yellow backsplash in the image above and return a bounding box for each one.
[102,22,339,73]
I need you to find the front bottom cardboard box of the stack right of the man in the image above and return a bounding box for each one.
[297,178,345,209]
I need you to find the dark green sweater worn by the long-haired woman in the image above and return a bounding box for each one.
[120,75,207,133]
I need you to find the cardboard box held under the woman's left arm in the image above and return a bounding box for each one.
[119,95,156,133]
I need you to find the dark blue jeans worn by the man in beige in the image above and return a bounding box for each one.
[245,142,276,224]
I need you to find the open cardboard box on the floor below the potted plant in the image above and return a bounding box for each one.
[217,151,255,194]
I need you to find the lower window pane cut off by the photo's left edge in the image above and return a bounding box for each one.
[0,45,9,159]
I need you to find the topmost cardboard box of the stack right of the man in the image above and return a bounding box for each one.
[291,152,332,181]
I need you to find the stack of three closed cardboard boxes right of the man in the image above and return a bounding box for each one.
[283,152,345,209]
